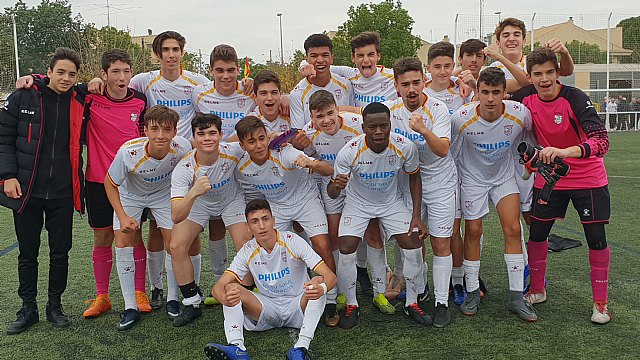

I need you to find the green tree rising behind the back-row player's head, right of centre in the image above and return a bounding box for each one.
[333,0,421,67]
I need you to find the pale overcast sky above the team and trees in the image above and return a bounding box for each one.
[12,0,640,63]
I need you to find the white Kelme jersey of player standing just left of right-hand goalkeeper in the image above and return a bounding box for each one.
[451,100,532,186]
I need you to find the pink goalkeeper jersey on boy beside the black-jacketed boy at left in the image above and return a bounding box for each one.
[86,89,147,183]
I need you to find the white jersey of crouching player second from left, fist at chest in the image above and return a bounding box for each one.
[171,143,244,204]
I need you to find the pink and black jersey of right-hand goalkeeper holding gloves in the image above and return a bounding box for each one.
[511,85,609,190]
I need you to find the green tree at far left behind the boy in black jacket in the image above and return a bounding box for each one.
[5,0,82,74]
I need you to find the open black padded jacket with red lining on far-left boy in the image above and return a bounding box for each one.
[0,82,85,213]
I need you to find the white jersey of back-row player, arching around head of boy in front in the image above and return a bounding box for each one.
[289,74,354,129]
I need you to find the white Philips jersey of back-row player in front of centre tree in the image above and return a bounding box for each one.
[331,65,398,107]
